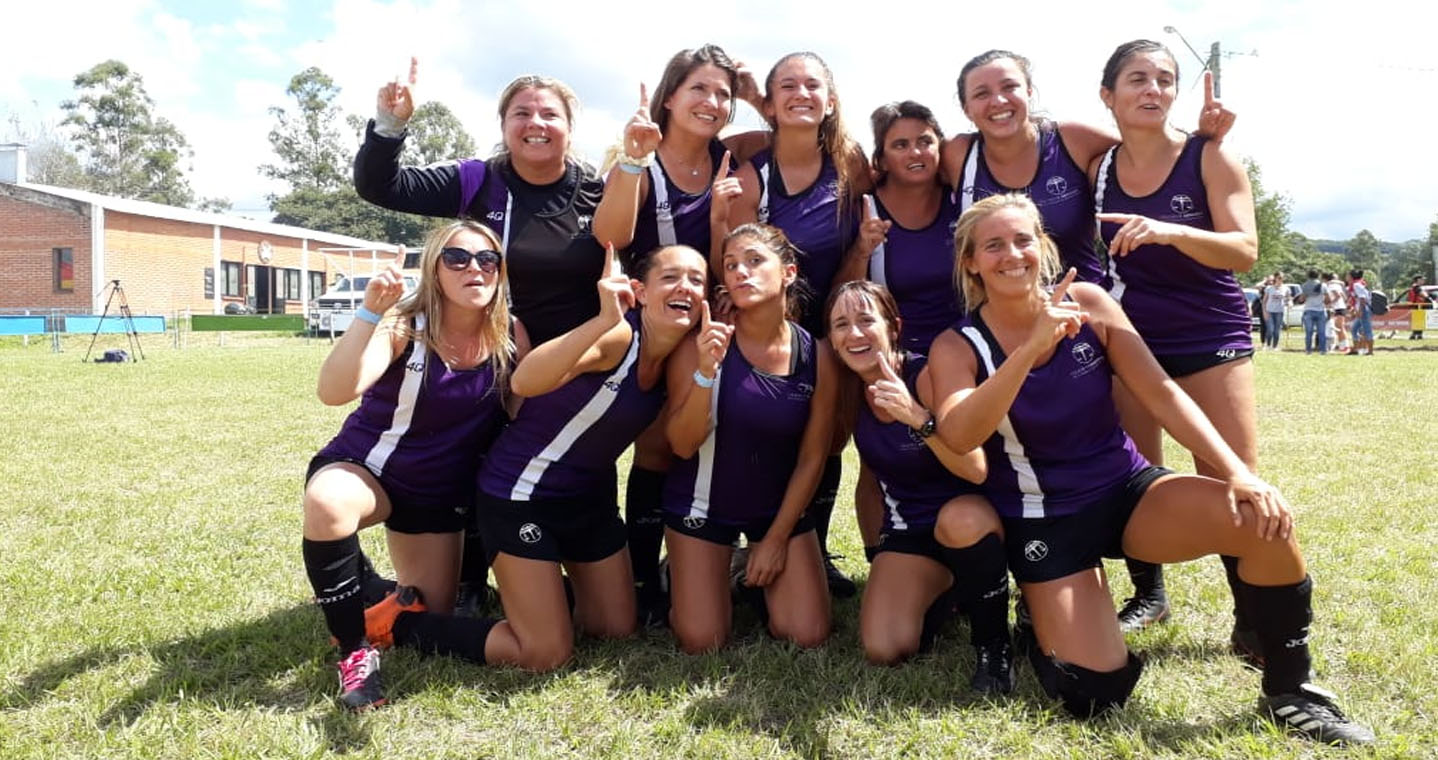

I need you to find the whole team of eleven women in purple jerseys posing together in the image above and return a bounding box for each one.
[302,40,1373,744]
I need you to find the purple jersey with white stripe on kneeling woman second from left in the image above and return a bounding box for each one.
[479,310,664,501]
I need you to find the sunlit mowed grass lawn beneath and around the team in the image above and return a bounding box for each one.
[0,336,1438,760]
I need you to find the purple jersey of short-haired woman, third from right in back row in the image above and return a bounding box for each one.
[869,193,963,353]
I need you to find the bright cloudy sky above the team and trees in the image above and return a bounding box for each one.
[0,0,1438,241]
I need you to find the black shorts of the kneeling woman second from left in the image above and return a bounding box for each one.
[476,490,627,562]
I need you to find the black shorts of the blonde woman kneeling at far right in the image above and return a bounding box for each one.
[1002,465,1173,583]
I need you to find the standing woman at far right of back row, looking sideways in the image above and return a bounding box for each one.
[1089,40,1278,640]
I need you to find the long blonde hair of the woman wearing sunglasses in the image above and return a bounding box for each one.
[395,220,515,388]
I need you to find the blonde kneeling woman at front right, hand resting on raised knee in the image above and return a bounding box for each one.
[930,194,1373,743]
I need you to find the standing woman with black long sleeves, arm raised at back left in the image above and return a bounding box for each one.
[355,59,604,609]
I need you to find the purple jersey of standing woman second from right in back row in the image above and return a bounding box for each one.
[959,119,1109,287]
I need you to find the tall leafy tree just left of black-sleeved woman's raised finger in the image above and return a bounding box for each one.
[260,66,352,192]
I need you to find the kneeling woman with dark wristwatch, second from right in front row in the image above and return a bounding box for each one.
[827,280,1014,694]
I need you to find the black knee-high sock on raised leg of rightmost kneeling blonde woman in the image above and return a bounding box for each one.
[1240,578,1313,694]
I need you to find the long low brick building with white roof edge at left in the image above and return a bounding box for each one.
[0,145,395,315]
